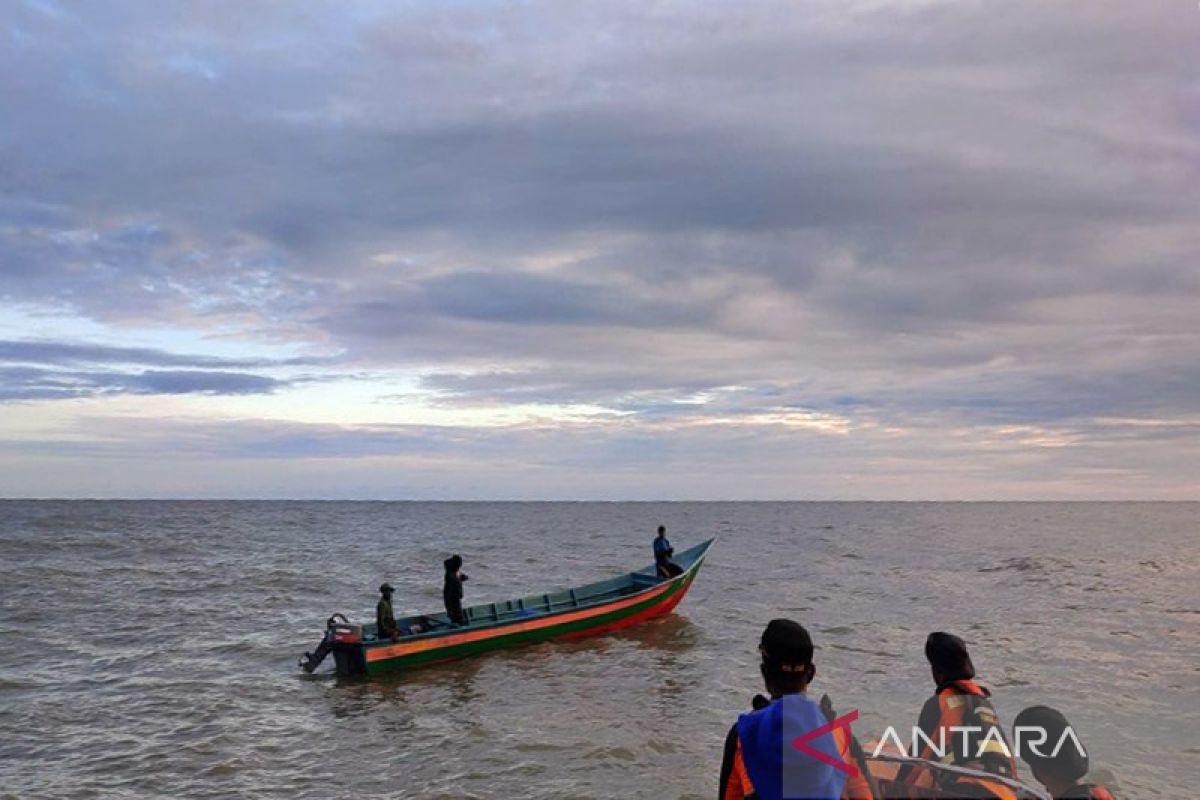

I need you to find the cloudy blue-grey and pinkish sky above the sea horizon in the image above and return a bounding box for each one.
[0,0,1200,500]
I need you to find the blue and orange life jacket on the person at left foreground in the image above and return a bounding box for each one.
[726,694,850,800]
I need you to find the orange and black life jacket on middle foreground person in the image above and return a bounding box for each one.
[920,680,1016,777]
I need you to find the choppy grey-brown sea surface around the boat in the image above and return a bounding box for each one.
[0,500,1200,800]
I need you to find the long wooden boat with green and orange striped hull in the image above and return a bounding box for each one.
[314,539,715,675]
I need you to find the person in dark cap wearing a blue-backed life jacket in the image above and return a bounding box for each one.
[719,619,872,800]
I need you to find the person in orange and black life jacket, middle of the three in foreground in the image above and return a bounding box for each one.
[899,631,1016,798]
